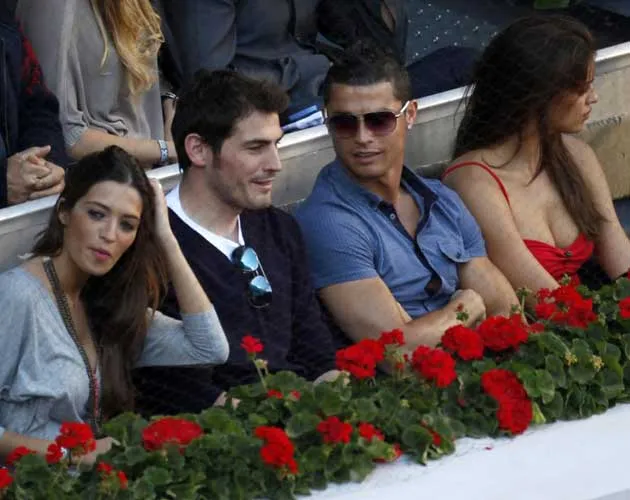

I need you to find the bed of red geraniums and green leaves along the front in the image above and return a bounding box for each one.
[0,277,630,500]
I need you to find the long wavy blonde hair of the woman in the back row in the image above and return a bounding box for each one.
[90,0,164,95]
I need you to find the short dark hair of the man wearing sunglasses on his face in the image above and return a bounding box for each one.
[322,40,412,104]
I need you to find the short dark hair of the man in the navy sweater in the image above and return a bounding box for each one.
[171,69,289,172]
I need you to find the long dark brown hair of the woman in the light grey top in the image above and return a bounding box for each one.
[33,146,167,418]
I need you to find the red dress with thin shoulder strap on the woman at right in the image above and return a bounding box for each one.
[442,161,595,280]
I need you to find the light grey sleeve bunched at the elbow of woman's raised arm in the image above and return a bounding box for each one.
[136,308,229,368]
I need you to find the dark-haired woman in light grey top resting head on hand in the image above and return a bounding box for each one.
[0,146,228,463]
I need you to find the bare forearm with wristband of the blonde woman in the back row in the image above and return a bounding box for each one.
[70,128,175,166]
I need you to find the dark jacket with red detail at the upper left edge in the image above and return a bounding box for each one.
[0,2,69,207]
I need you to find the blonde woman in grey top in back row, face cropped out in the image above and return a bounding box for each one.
[17,0,177,168]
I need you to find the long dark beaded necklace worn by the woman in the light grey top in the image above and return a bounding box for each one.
[43,257,101,436]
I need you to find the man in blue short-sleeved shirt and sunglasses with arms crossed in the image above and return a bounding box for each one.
[296,45,517,347]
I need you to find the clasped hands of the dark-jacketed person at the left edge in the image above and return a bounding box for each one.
[7,146,65,205]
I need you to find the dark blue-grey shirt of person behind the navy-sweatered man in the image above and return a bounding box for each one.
[160,0,329,102]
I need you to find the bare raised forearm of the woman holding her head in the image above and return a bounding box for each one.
[162,236,212,314]
